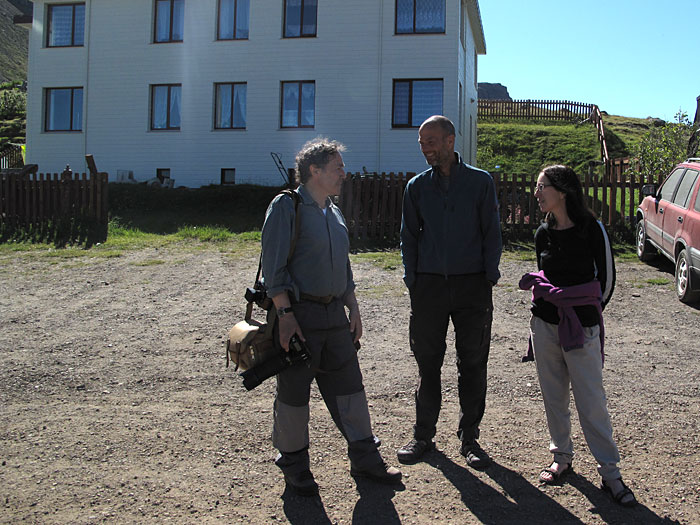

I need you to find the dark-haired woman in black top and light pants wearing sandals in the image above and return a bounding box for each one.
[521,166,636,506]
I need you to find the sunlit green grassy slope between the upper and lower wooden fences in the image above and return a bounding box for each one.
[477,115,654,174]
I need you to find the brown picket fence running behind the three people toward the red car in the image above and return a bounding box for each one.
[338,158,663,242]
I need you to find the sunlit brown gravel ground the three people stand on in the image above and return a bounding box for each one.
[0,245,700,524]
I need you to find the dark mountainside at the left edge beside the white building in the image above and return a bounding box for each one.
[0,0,32,82]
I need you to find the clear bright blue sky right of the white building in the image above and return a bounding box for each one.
[478,0,700,120]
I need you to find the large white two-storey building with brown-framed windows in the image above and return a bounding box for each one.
[20,0,486,187]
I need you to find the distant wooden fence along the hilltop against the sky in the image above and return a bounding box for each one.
[477,99,595,122]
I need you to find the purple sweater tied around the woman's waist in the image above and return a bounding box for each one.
[518,271,605,361]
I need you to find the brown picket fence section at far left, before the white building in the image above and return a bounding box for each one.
[0,166,108,236]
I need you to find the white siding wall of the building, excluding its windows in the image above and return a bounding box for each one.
[27,0,484,186]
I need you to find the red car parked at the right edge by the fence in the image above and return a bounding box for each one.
[637,158,700,303]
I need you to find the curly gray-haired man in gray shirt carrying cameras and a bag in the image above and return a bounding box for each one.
[262,139,401,495]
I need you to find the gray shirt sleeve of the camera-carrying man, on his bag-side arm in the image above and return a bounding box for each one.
[261,195,295,297]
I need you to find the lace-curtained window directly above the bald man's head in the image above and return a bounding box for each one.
[391,79,442,128]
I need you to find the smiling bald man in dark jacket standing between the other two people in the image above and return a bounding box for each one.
[397,115,502,469]
